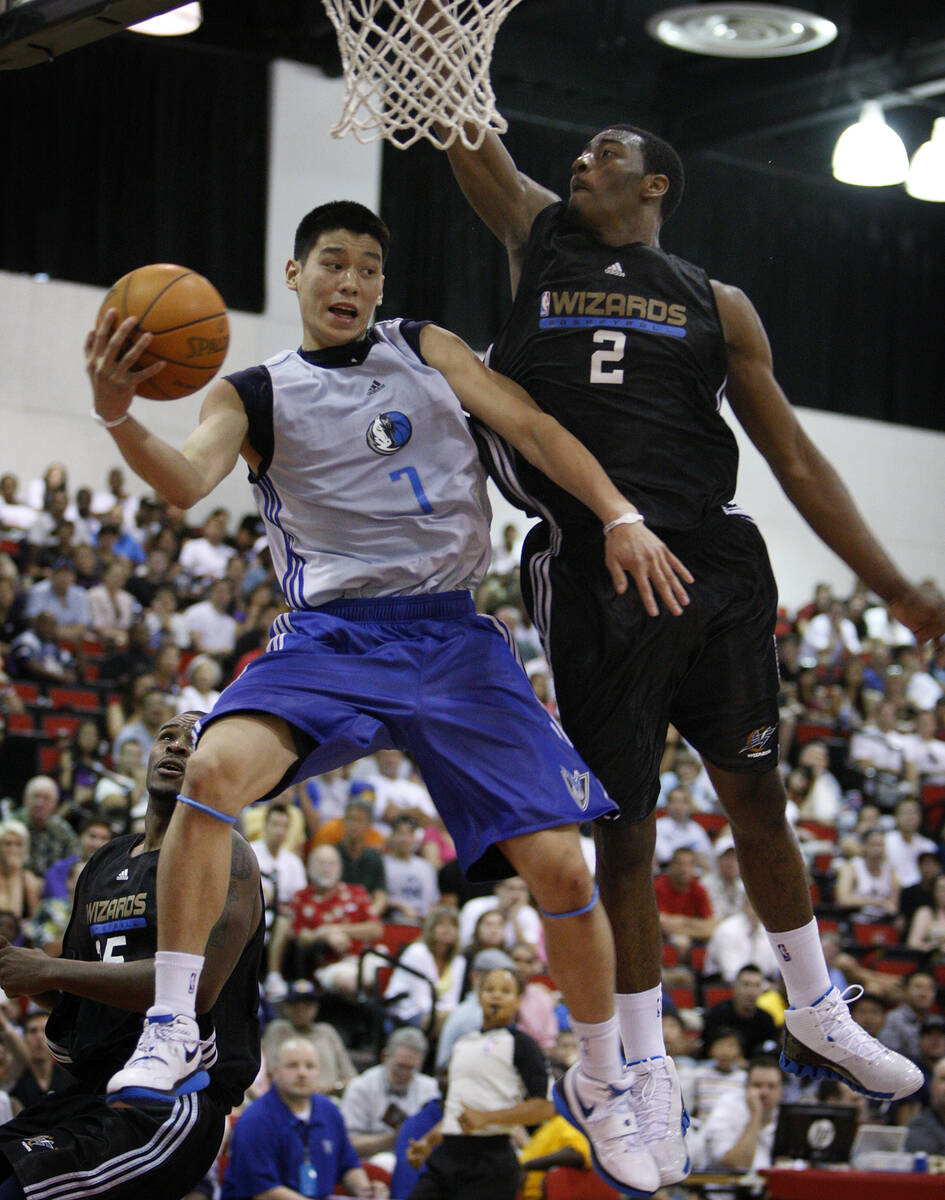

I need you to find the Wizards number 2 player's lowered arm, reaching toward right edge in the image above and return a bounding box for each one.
[712,281,945,642]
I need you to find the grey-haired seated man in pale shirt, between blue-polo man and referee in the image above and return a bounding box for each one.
[342,1025,440,1162]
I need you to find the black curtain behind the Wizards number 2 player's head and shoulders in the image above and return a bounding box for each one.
[381,121,945,430]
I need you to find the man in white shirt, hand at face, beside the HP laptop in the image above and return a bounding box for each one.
[703,1055,783,1171]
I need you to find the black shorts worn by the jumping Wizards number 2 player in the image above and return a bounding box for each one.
[522,510,778,822]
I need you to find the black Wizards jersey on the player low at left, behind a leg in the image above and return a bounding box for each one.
[46,834,265,1106]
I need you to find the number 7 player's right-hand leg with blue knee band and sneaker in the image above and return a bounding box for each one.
[499,826,660,1194]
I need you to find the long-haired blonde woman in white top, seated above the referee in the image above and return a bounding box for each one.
[385,902,465,1037]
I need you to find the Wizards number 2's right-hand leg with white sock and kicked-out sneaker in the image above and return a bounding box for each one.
[706,762,922,1099]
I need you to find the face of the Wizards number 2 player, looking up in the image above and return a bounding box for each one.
[567,130,644,230]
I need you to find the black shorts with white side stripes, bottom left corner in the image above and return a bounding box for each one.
[0,1088,225,1200]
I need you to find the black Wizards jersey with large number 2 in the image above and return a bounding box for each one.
[476,203,738,532]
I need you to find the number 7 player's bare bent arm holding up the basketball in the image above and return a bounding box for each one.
[85,308,248,509]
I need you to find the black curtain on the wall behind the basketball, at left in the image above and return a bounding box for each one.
[0,34,269,312]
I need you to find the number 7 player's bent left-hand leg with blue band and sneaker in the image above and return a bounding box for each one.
[108,713,299,1099]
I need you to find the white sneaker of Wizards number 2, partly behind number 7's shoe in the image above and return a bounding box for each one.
[624,1055,690,1188]
